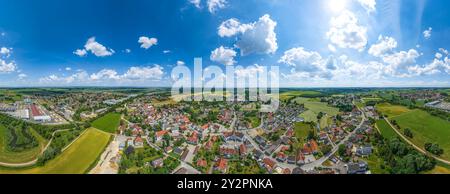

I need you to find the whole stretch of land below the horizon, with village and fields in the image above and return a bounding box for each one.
[0,88,450,174]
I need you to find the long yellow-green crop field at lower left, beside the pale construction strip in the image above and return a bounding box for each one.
[0,128,111,174]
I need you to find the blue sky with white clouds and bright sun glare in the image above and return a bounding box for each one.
[0,0,450,87]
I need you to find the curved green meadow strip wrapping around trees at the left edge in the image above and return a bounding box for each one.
[0,125,47,163]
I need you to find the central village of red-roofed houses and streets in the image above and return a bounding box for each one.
[107,93,377,174]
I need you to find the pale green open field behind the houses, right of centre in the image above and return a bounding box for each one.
[295,98,339,128]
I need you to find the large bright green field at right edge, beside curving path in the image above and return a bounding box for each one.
[392,110,450,160]
